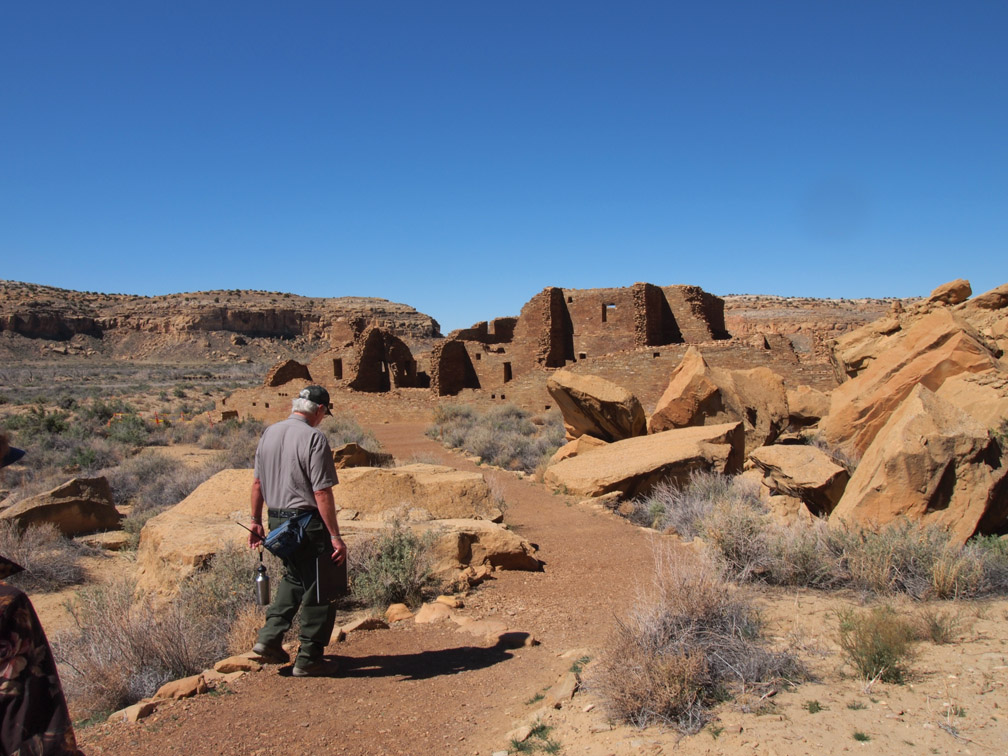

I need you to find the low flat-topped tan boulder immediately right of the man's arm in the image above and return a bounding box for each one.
[333,463,501,520]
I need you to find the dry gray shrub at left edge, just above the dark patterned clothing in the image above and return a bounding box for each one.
[0,520,84,591]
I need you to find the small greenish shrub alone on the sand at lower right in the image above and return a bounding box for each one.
[839,605,917,682]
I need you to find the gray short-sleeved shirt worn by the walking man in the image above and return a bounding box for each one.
[255,412,339,509]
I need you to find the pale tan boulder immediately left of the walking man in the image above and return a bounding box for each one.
[136,470,253,596]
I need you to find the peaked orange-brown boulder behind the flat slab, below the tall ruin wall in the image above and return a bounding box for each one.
[648,347,788,452]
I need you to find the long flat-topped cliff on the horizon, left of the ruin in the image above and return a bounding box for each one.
[0,281,440,343]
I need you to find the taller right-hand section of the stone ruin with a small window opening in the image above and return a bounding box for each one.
[430,283,729,396]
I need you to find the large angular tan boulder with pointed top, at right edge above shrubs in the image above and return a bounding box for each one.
[830,385,1008,543]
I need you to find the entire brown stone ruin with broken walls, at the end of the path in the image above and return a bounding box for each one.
[218,283,729,420]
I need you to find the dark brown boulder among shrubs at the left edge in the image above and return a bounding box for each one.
[0,477,122,536]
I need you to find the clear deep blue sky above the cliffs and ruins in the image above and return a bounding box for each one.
[0,0,1008,333]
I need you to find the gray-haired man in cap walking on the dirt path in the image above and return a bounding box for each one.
[249,386,347,677]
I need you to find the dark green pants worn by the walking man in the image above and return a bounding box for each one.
[257,516,336,666]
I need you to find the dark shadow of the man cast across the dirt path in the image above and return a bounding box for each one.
[280,632,528,679]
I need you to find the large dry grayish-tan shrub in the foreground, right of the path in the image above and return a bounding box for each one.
[588,550,804,733]
